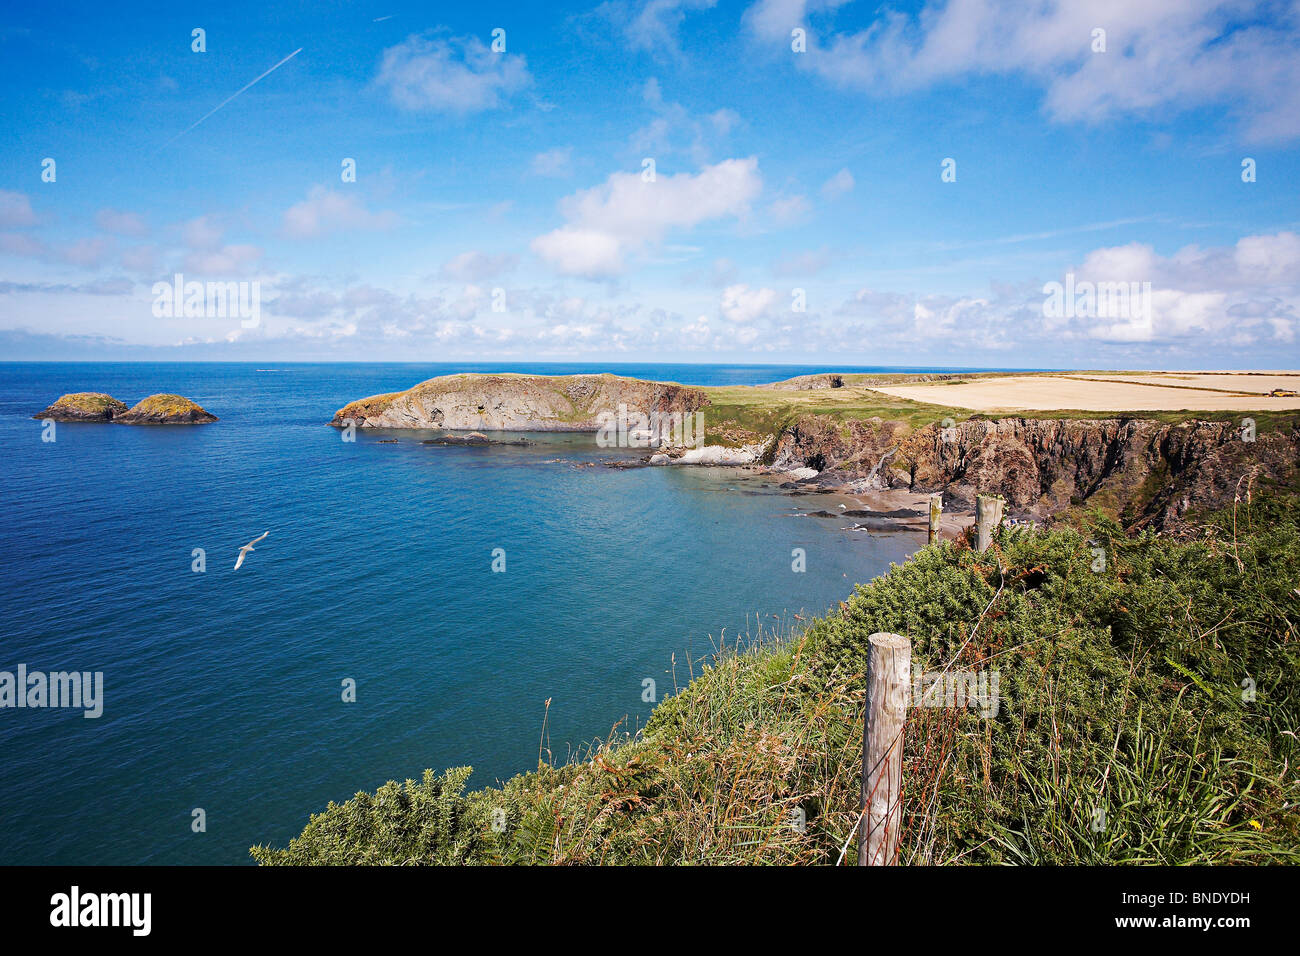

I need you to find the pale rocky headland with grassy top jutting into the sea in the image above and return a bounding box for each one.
[330,375,709,432]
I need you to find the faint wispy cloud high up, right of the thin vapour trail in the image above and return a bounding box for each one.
[376,36,533,113]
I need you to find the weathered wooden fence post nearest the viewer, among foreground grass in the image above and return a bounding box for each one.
[858,632,911,866]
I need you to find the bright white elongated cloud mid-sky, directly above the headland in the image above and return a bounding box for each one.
[532,157,762,278]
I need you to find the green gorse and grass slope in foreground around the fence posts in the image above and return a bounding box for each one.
[252,488,1300,864]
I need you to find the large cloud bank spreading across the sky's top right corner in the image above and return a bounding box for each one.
[745,0,1300,139]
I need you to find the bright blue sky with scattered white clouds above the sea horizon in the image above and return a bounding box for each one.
[0,0,1300,368]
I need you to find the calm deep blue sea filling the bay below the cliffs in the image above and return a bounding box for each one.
[0,363,956,864]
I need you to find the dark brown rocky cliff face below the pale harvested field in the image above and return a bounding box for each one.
[774,416,1300,529]
